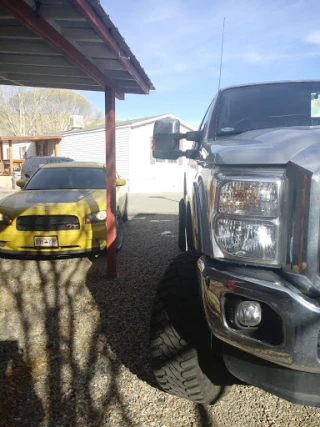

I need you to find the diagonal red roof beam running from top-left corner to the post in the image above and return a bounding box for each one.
[0,0,124,99]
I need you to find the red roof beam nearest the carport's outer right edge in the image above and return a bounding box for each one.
[71,0,149,93]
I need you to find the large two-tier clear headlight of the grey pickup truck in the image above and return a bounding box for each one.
[211,171,284,266]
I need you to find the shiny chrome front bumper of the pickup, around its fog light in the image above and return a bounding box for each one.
[198,256,320,373]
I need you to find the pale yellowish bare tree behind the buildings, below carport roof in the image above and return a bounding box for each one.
[0,86,103,136]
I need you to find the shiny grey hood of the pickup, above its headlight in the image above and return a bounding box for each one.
[209,127,320,165]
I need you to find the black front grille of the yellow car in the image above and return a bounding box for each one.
[17,215,80,231]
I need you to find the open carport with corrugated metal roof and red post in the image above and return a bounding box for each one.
[0,0,154,277]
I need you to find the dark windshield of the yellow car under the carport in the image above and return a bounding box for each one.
[24,167,106,190]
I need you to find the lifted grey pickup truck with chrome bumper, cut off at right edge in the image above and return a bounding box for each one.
[151,81,320,406]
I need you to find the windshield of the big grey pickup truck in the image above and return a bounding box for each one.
[217,82,320,136]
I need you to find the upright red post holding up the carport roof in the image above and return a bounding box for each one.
[105,88,117,278]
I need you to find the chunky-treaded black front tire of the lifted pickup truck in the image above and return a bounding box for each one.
[151,252,232,404]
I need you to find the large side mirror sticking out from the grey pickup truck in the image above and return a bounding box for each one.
[153,118,182,160]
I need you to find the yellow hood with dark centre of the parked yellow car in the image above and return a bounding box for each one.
[0,190,106,213]
